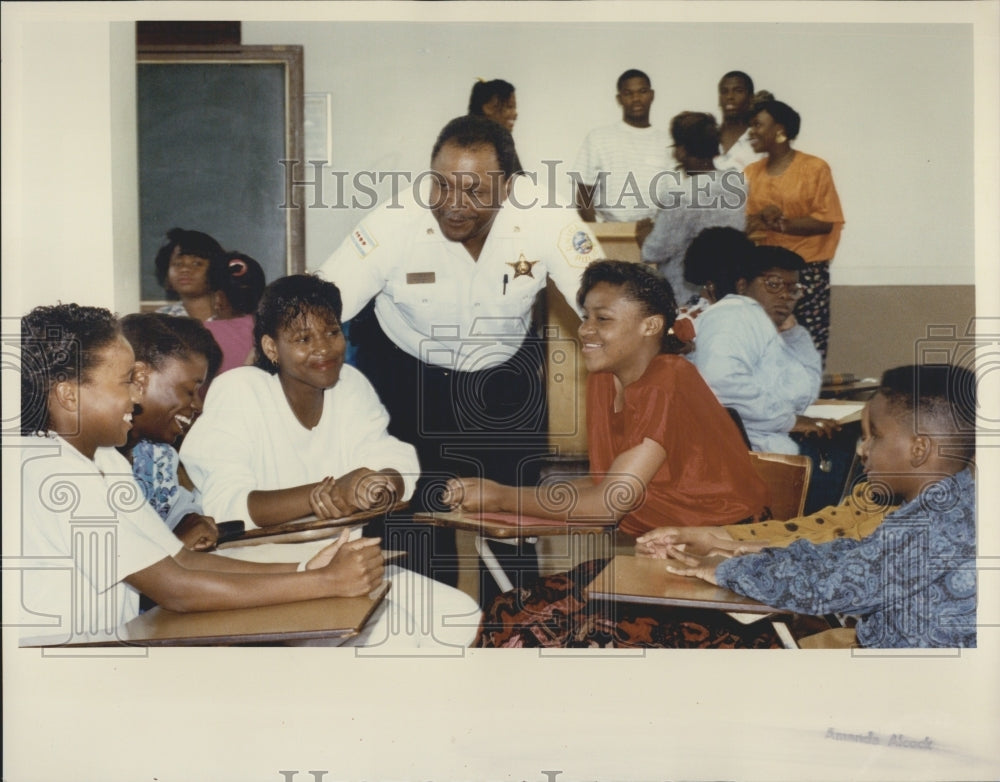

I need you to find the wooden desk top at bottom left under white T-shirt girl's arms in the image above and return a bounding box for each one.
[20,581,392,648]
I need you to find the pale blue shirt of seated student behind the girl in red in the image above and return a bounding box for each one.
[688,294,823,453]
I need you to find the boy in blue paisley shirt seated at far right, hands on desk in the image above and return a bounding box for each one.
[647,365,976,648]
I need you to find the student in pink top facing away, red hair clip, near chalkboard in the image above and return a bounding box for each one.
[205,252,267,376]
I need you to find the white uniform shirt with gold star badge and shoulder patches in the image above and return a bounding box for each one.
[320,177,603,374]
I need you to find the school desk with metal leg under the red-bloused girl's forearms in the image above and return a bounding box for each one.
[413,511,615,592]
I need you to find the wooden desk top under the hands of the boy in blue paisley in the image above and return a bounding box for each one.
[587,555,784,614]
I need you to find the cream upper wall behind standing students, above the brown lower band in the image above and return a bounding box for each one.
[243,21,973,285]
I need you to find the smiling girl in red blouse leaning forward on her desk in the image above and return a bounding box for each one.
[444,261,768,537]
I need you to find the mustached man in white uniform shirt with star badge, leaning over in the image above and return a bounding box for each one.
[319,116,601,583]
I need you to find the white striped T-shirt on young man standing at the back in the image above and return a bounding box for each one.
[573,121,675,223]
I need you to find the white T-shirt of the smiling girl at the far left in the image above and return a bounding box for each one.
[21,435,182,637]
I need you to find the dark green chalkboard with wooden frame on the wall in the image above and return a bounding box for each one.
[136,46,305,306]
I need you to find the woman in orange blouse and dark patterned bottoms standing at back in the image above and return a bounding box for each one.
[744,100,844,362]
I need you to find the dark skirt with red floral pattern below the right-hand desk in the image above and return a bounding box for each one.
[474,559,796,649]
